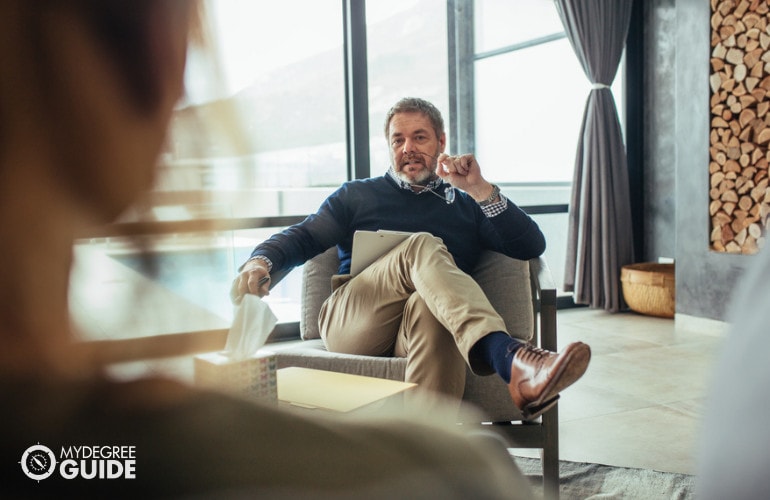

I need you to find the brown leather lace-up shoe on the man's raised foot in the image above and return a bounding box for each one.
[508,342,591,420]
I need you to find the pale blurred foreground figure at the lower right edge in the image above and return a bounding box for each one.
[695,244,770,500]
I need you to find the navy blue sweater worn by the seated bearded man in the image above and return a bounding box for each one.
[251,175,545,274]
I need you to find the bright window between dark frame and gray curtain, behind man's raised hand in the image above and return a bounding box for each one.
[458,0,622,288]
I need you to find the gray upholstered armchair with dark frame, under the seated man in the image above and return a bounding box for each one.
[276,248,559,498]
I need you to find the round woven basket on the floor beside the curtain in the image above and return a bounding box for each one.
[620,262,676,318]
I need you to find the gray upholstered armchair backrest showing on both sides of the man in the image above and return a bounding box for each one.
[300,248,534,340]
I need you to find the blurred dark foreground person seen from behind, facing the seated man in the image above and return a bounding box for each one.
[0,0,530,498]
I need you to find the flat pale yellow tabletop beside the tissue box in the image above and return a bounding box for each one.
[277,366,417,413]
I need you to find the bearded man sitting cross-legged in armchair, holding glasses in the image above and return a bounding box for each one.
[231,97,591,420]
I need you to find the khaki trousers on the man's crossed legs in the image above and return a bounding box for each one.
[319,233,506,401]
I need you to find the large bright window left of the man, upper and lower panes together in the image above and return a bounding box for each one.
[71,0,348,338]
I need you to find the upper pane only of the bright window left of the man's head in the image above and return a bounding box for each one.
[162,0,347,217]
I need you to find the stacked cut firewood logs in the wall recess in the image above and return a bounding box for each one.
[709,0,770,254]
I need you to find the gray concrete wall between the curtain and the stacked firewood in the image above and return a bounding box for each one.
[644,0,754,320]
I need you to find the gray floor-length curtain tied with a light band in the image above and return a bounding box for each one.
[555,0,634,312]
